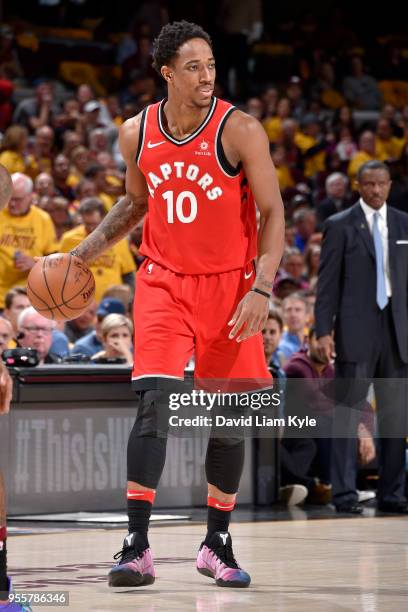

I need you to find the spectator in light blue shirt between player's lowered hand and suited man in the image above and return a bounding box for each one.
[279,293,308,360]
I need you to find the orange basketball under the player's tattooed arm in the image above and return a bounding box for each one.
[27,253,95,321]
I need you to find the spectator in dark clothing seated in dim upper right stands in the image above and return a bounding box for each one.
[343,57,382,110]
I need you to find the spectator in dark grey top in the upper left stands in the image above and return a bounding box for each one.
[13,81,58,133]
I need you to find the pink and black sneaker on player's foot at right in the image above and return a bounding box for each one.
[197,531,251,588]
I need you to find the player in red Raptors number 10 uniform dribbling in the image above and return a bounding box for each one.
[67,21,284,587]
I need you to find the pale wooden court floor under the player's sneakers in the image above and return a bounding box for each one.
[5,518,408,612]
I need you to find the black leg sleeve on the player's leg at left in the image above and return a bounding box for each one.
[127,390,169,489]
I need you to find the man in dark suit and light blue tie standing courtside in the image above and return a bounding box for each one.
[315,160,408,514]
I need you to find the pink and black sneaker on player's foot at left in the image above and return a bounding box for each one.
[109,531,156,587]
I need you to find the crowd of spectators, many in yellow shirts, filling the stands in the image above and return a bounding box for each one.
[0,0,408,510]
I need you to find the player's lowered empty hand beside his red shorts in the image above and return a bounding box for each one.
[228,291,269,342]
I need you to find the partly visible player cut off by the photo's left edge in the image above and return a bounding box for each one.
[0,165,31,612]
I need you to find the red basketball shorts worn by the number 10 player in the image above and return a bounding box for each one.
[132,259,272,390]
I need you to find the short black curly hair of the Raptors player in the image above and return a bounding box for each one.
[153,20,212,74]
